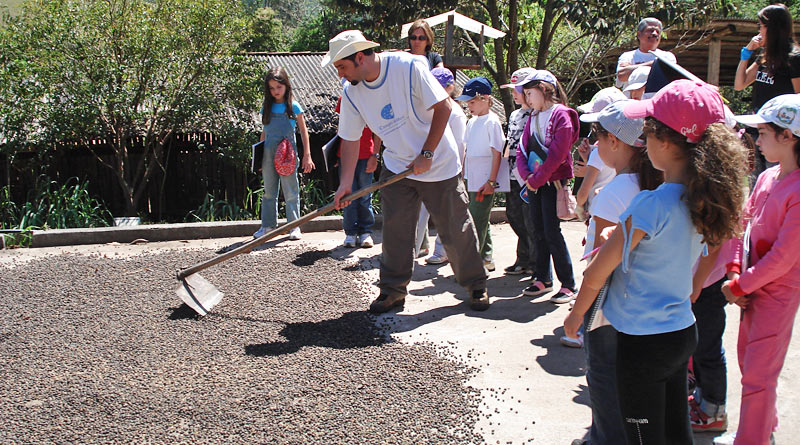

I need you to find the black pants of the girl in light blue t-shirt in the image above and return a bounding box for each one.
[617,325,697,445]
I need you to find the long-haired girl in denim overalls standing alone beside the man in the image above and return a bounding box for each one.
[253,67,314,240]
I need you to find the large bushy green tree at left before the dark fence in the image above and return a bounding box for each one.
[0,0,259,215]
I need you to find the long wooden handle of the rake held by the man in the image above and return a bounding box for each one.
[178,168,414,280]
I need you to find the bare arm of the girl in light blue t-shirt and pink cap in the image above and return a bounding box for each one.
[564,218,645,338]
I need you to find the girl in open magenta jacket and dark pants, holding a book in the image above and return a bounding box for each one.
[515,70,580,304]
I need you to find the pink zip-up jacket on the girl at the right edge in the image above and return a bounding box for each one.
[728,166,800,296]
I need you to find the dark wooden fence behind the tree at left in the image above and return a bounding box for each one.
[0,135,334,222]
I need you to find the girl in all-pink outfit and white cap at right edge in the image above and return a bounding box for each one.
[714,94,800,445]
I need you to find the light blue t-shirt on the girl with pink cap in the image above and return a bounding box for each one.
[603,183,704,335]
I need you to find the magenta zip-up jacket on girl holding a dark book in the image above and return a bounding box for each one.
[517,104,580,189]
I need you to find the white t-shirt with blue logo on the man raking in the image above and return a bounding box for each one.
[338,51,461,182]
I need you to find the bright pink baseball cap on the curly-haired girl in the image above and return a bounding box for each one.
[624,79,725,143]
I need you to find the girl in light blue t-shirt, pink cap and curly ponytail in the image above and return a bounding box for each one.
[564,79,746,444]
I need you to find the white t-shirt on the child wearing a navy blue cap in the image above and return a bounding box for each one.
[464,111,509,192]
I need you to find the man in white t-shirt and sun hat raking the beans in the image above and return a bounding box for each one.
[322,30,489,313]
